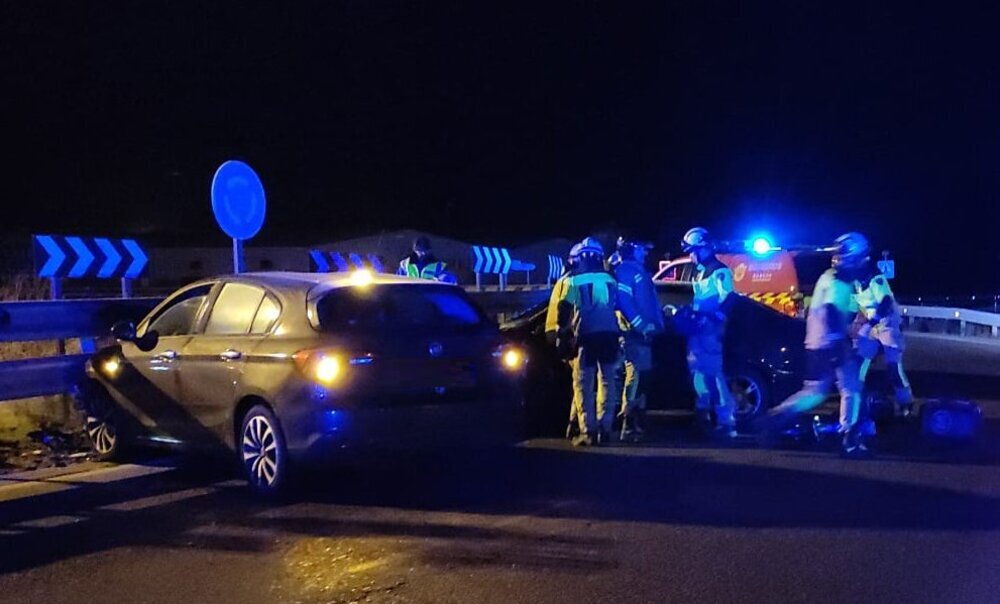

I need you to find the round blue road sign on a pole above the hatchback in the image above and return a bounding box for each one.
[212,160,267,241]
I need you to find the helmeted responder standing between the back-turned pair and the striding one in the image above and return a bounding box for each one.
[675,227,737,438]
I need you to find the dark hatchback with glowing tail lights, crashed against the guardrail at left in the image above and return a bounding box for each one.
[81,271,525,491]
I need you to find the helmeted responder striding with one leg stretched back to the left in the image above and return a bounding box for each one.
[764,233,869,456]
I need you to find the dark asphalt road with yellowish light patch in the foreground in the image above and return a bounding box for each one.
[0,338,1000,604]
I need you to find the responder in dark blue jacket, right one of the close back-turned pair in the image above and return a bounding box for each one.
[613,238,663,440]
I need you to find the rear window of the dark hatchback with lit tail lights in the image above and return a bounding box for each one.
[316,284,486,331]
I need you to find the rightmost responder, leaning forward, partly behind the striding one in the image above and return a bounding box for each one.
[854,258,913,418]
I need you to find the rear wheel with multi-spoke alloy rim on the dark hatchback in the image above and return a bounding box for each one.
[239,405,288,495]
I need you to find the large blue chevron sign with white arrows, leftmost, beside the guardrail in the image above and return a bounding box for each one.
[32,235,149,279]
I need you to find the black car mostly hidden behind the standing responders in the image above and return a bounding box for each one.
[503,285,805,434]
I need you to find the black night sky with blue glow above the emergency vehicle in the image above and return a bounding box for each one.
[0,0,1000,293]
